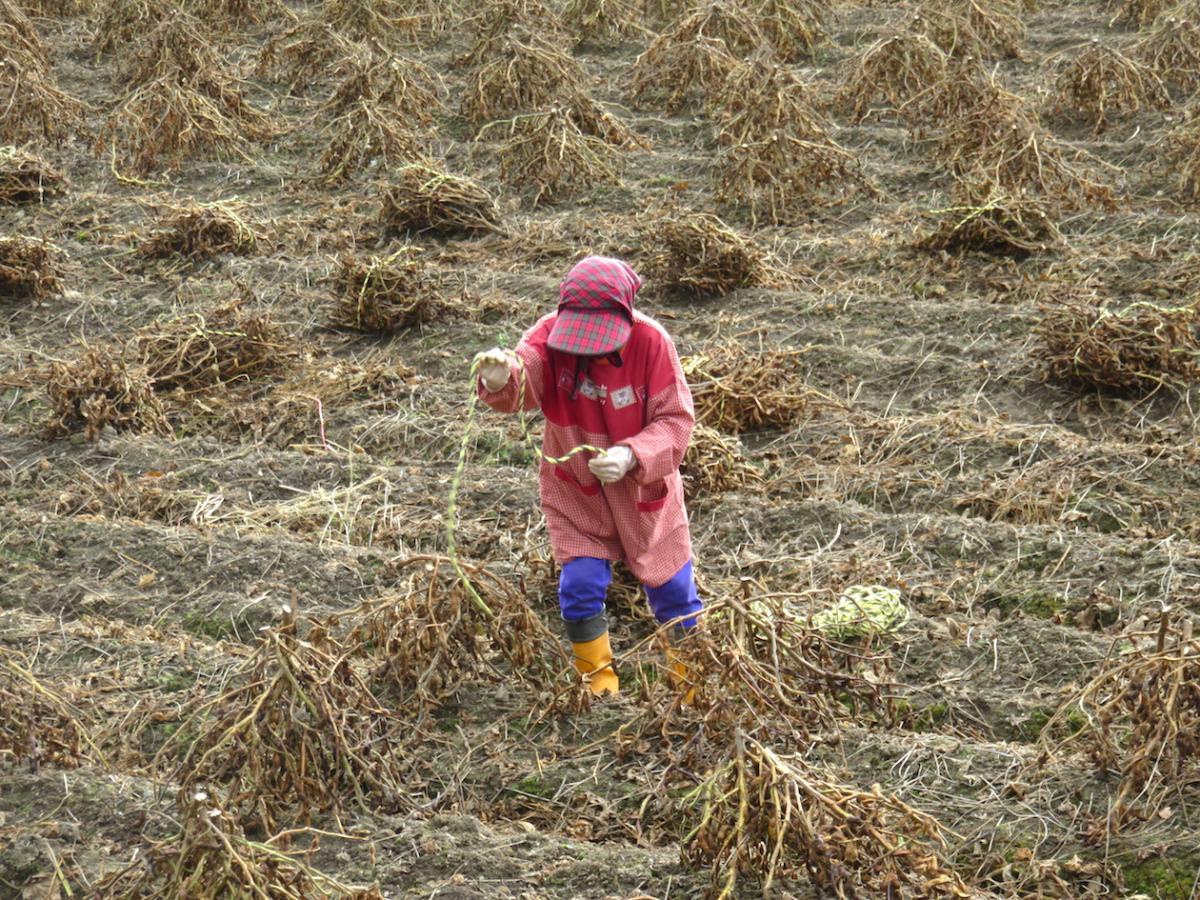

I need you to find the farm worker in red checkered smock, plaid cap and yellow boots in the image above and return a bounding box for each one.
[475,257,701,696]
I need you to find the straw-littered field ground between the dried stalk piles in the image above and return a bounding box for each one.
[7,0,1200,900]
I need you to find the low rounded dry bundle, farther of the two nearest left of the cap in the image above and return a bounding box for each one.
[379,161,500,238]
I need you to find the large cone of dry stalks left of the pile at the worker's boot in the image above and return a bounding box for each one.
[160,608,412,832]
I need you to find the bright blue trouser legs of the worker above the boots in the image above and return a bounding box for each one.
[558,557,701,643]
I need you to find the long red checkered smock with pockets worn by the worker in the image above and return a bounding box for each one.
[479,312,695,587]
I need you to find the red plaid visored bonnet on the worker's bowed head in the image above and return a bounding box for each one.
[546,257,642,356]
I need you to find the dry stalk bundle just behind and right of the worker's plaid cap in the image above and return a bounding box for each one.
[643,212,785,298]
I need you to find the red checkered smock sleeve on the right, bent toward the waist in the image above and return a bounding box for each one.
[620,332,696,485]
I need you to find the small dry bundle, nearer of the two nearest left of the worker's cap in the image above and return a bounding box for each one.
[331,246,451,335]
